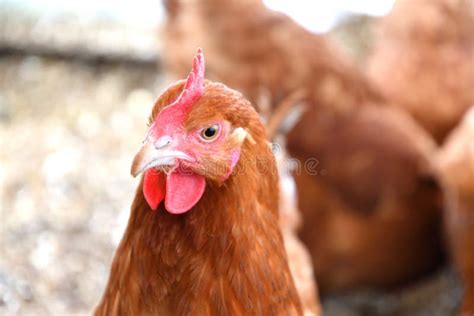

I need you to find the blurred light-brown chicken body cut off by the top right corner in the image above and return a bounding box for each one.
[368,0,474,143]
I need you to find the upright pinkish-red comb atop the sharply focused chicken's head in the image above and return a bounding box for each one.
[170,48,205,112]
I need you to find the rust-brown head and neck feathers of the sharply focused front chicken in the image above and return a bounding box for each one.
[95,58,302,315]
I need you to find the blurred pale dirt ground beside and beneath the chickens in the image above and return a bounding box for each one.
[0,55,461,316]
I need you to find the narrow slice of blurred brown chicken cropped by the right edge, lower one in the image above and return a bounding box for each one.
[436,108,474,316]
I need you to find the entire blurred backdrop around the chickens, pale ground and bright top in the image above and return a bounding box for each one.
[0,0,470,315]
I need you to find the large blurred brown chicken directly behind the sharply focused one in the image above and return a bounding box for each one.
[163,0,442,292]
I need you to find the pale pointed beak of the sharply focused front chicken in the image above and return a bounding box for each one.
[130,142,191,177]
